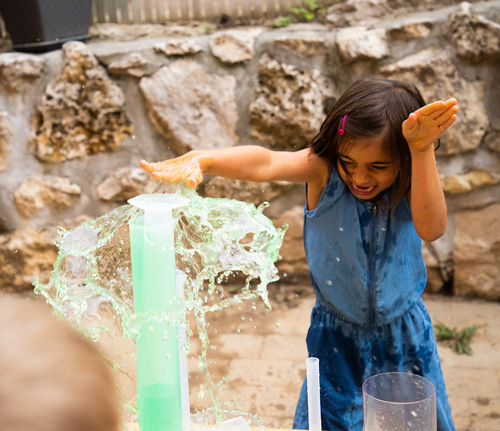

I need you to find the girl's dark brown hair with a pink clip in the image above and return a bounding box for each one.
[311,77,425,209]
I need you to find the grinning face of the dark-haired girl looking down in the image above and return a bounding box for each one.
[337,134,398,200]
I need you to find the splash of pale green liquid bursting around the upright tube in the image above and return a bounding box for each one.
[34,183,286,431]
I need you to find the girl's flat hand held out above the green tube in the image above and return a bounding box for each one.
[139,152,213,188]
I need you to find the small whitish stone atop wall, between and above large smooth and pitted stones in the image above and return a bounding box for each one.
[209,28,262,64]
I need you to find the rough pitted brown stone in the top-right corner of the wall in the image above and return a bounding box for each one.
[443,2,500,63]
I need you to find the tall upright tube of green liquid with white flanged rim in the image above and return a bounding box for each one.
[129,195,187,431]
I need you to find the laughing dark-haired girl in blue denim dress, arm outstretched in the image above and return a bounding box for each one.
[141,77,458,431]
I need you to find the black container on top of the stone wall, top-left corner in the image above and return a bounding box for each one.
[0,0,92,52]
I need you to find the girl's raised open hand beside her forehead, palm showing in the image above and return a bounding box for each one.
[402,99,458,151]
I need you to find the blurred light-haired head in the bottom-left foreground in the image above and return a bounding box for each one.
[0,296,121,431]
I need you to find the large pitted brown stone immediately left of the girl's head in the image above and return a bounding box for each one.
[249,54,333,149]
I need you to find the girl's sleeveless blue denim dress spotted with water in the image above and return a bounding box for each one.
[293,168,455,431]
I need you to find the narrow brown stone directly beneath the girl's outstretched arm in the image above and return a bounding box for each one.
[203,177,293,205]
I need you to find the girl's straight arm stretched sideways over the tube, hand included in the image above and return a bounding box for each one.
[140,145,328,188]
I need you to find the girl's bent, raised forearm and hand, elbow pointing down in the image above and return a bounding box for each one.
[402,99,458,241]
